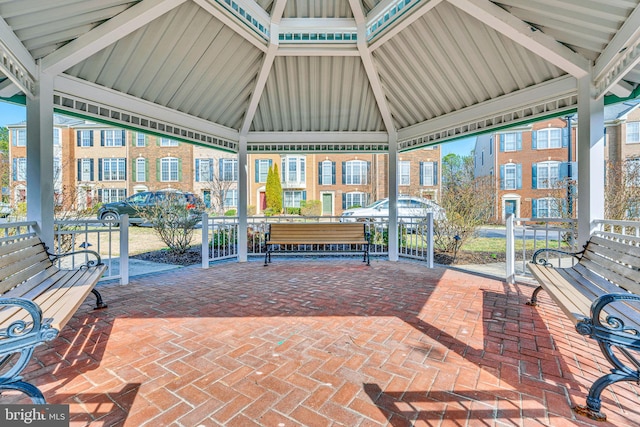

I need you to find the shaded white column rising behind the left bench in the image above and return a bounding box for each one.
[27,73,54,251]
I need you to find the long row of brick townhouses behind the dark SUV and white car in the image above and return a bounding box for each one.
[9,115,440,215]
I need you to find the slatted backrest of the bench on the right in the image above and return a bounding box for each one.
[580,236,640,295]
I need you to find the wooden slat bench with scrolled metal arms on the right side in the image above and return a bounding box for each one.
[528,235,640,420]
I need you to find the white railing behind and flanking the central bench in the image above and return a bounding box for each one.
[202,214,433,268]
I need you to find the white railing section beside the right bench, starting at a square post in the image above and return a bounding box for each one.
[505,214,579,283]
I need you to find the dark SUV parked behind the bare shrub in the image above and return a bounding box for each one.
[98,191,204,222]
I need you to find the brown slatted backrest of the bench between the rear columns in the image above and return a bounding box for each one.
[269,222,365,241]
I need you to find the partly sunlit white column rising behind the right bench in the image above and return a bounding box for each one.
[577,76,605,244]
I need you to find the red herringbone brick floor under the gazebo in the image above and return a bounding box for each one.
[0,259,640,427]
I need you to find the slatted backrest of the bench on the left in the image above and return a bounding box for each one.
[0,237,52,295]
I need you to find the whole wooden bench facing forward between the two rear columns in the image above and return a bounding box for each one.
[264,222,370,266]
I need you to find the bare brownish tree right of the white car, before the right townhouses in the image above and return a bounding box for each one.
[434,153,495,252]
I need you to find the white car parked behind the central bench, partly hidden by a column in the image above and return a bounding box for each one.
[340,196,446,224]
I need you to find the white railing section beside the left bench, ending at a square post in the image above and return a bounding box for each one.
[54,215,129,285]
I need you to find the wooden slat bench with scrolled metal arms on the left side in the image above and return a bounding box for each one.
[0,236,107,404]
